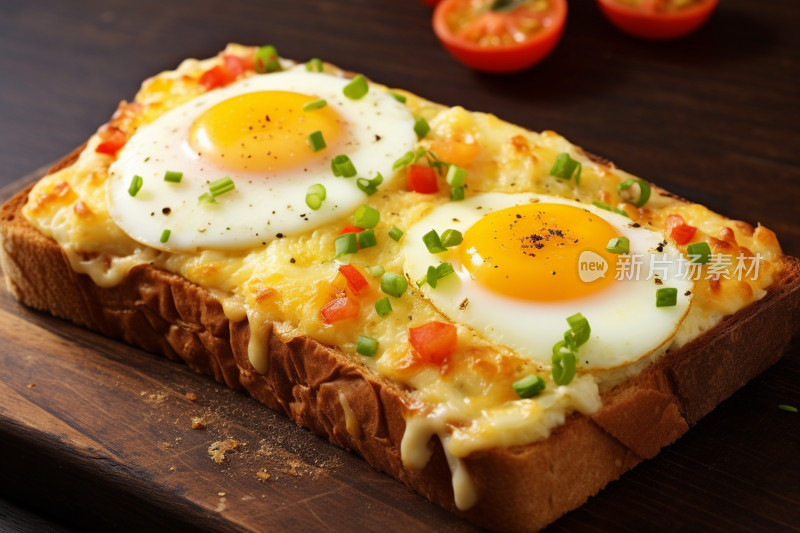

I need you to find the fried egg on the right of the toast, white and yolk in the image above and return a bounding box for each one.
[404,193,694,370]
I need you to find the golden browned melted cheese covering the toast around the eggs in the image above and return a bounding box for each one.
[23,46,781,509]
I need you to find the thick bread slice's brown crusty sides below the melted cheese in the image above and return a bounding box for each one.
[0,149,800,531]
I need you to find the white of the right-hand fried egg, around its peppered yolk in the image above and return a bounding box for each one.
[403,193,694,370]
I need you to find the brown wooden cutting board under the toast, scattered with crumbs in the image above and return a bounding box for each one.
[0,167,800,532]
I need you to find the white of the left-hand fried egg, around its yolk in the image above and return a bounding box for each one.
[107,65,416,251]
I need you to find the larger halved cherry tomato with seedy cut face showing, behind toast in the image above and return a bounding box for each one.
[433,0,567,72]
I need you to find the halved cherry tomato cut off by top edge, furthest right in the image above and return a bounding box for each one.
[597,0,719,41]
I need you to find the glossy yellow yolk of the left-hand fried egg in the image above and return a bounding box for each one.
[189,91,344,172]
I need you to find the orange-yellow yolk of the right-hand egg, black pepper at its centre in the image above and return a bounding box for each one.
[458,203,619,302]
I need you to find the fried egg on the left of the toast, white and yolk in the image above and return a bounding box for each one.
[107,66,416,252]
